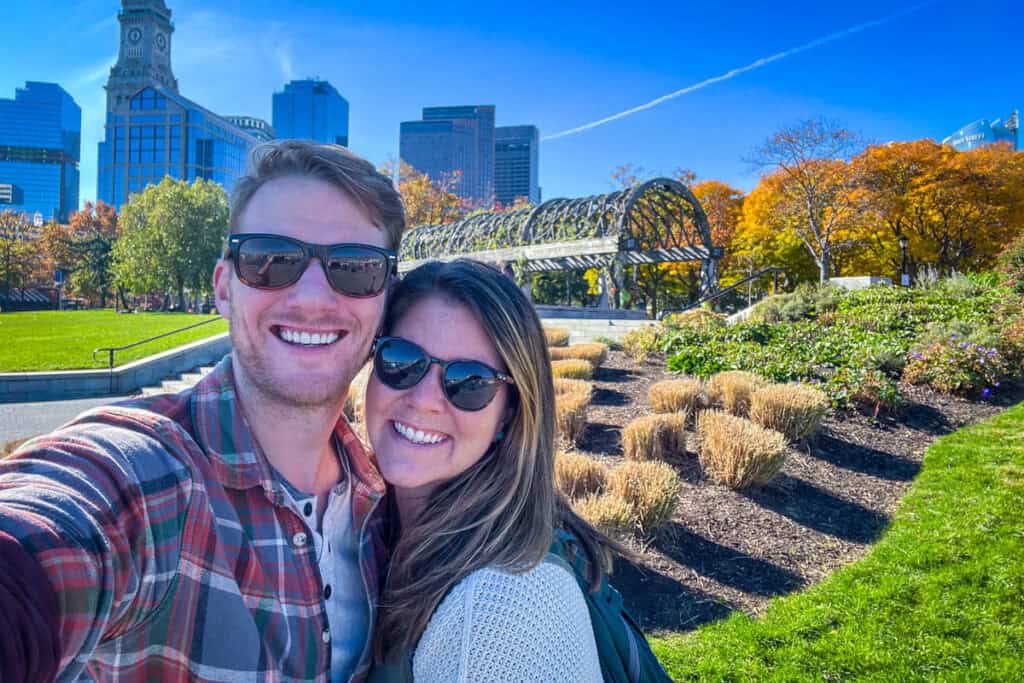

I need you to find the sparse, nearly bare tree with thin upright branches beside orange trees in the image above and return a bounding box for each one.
[753,119,862,283]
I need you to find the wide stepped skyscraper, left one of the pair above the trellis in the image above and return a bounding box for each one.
[398,104,495,206]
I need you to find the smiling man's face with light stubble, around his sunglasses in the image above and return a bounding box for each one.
[213,176,387,409]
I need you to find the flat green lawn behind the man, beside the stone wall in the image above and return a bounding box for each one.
[0,310,227,373]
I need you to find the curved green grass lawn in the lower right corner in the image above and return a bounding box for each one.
[652,405,1024,681]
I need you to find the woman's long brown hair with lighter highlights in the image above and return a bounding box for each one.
[374,259,622,661]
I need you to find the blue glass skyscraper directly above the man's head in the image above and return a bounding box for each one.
[273,80,348,147]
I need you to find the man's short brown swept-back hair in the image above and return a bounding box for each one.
[230,140,406,251]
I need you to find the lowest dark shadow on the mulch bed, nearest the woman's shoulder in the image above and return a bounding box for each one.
[611,559,734,632]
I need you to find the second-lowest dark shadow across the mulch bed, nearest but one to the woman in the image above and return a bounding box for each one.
[654,522,804,597]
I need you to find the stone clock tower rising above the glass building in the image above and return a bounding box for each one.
[106,0,178,112]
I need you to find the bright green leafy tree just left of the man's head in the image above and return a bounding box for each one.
[114,177,228,308]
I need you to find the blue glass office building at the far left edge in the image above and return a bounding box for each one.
[0,81,82,222]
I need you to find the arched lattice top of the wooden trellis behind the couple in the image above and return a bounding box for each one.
[399,178,722,294]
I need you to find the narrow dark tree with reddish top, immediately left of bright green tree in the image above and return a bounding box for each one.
[69,202,118,307]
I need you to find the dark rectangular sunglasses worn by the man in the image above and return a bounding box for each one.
[226,232,398,298]
